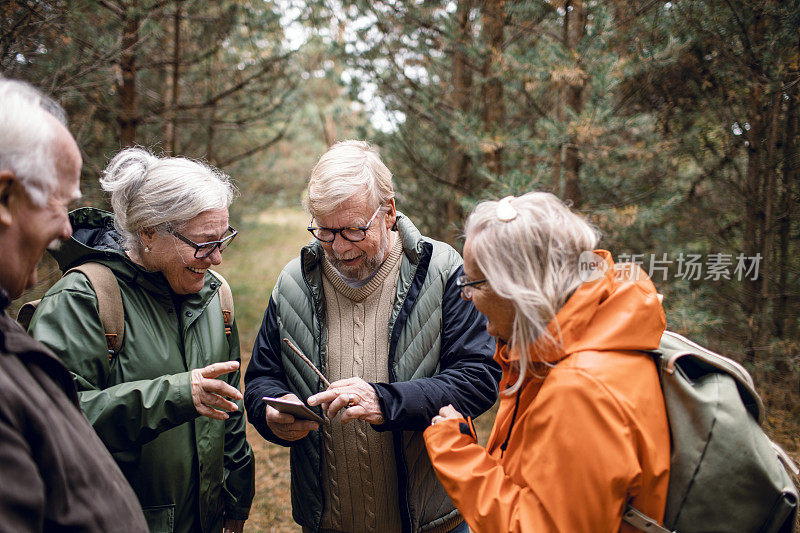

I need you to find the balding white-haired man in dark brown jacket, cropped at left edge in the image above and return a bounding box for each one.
[0,78,147,532]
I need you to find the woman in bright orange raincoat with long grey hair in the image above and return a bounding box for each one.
[425,193,670,533]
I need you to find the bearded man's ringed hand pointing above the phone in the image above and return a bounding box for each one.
[308,378,384,424]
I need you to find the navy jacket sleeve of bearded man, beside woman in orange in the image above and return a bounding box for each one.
[372,267,501,431]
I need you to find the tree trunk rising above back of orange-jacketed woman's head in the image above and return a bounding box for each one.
[564,0,586,207]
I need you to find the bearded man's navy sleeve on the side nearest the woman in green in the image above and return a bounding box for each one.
[244,297,293,446]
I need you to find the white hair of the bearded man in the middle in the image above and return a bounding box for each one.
[303,140,394,217]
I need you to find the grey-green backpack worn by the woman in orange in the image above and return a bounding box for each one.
[623,331,798,533]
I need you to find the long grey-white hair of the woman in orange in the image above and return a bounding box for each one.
[465,192,600,392]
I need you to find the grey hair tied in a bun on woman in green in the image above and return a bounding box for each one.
[100,148,236,250]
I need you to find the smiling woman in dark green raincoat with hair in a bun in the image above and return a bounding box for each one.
[30,148,254,533]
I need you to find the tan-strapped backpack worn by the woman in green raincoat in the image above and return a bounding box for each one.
[17,261,234,361]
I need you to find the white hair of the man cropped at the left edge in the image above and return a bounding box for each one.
[0,77,67,206]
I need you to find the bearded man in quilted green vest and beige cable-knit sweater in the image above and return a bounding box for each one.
[245,141,499,533]
